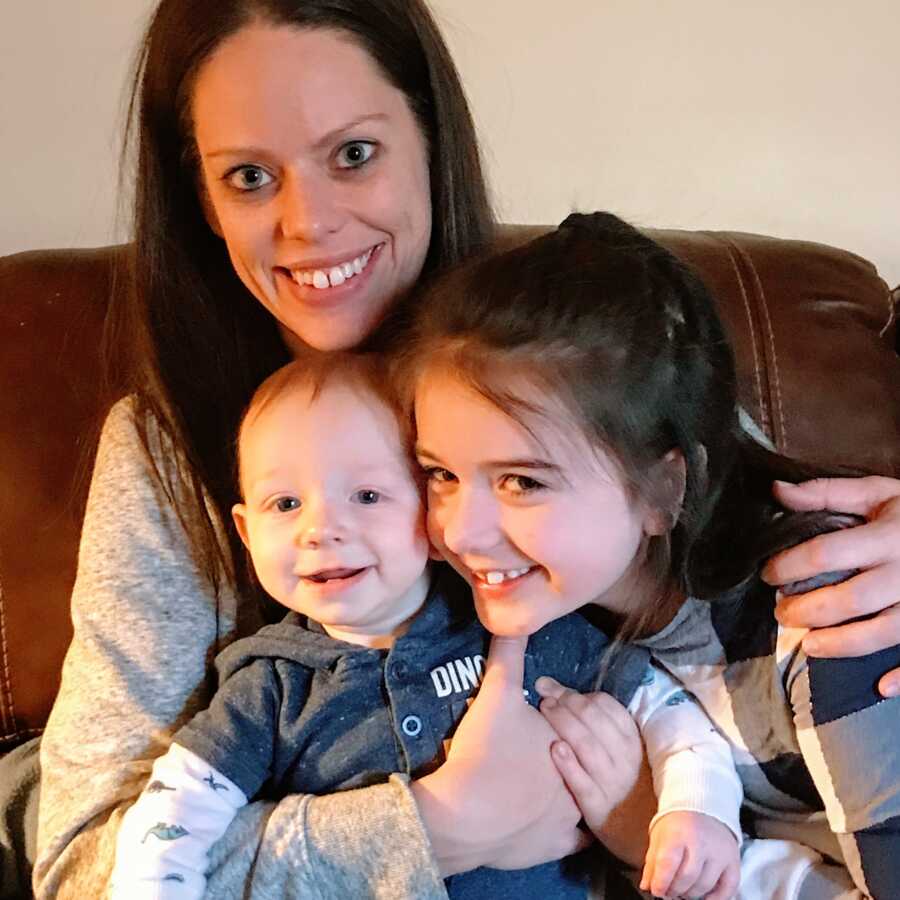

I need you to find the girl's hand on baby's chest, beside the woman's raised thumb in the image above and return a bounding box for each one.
[536,677,656,868]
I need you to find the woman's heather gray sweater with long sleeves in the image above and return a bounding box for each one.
[34,400,446,900]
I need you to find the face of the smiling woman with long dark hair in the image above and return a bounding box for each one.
[192,24,431,350]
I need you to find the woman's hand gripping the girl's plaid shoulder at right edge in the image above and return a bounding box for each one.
[763,476,900,697]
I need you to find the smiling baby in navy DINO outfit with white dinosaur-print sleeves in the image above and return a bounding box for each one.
[113,353,741,900]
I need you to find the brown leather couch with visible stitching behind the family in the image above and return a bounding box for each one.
[0,228,900,753]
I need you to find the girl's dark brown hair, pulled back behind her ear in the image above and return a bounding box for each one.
[396,213,852,632]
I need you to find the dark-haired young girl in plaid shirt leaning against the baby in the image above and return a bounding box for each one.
[400,213,900,898]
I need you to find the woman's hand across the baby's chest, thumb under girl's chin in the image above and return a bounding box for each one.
[412,637,588,877]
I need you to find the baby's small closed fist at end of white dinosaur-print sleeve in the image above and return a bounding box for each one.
[641,812,741,900]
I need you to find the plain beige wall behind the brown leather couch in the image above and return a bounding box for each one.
[0,0,900,283]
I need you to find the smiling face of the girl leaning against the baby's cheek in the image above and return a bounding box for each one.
[416,371,649,635]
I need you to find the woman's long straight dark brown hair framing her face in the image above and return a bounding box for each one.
[104,0,493,589]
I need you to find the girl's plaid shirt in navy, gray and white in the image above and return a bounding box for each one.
[639,580,900,900]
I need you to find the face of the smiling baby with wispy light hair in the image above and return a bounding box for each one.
[233,384,429,646]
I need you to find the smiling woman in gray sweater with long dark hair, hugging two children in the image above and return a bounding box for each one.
[28,0,900,897]
